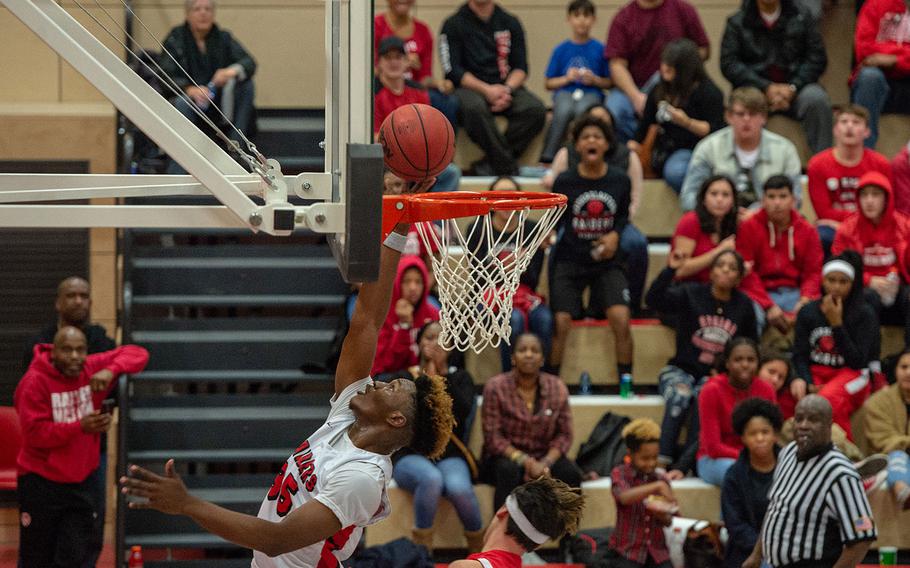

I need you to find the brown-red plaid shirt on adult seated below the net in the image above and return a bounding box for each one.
[482,371,572,459]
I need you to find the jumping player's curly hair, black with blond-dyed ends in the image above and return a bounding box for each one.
[408,374,455,460]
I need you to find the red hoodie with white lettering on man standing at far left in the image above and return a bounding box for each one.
[13,344,149,483]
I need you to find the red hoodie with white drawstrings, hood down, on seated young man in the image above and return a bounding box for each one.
[736,209,824,310]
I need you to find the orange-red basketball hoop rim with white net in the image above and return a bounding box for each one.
[383,191,566,353]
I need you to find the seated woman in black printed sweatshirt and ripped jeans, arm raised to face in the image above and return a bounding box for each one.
[647,250,757,473]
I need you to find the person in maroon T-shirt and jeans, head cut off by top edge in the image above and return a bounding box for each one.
[604,0,709,143]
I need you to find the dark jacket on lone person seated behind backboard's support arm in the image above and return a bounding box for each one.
[161,23,256,89]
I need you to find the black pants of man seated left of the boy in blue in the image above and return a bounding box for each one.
[455,87,547,175]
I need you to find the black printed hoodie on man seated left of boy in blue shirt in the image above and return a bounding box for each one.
[439,4,528,87]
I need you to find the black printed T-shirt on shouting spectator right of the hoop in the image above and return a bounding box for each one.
[553,167,632,266]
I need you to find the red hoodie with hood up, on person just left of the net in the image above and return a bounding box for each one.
[370,256,439,377]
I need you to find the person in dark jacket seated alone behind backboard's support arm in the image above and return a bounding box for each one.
[161,0,256,173]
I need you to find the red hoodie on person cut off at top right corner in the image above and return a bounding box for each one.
[851,0,910,81]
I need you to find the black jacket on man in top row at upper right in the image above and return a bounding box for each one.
[720,0,828,91]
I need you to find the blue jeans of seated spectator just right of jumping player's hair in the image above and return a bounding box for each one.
[392,454,483,531]
